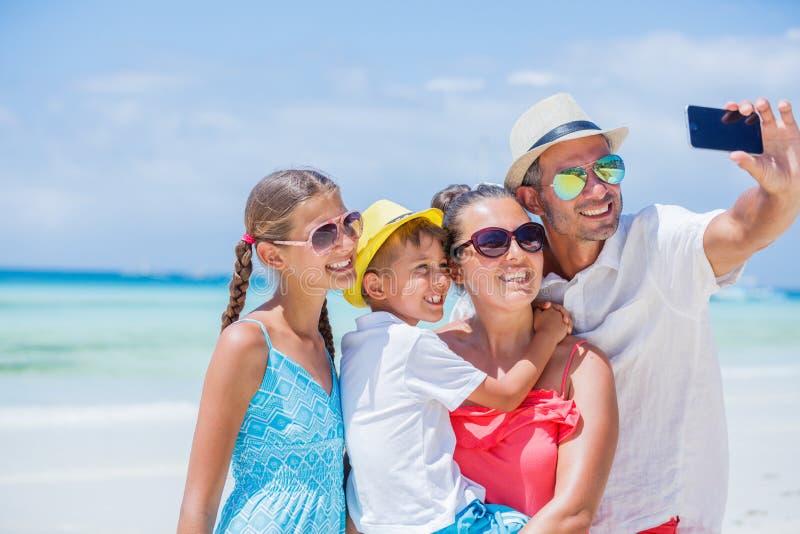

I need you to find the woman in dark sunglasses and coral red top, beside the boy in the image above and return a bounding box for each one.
[434,185,618,533]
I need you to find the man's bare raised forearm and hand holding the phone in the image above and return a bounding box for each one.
[703,98,800,276]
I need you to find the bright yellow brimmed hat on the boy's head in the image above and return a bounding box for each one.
[343,199,444,308]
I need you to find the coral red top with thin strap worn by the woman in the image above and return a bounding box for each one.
[450,341,586,516]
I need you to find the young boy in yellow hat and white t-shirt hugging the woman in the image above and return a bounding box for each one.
[340,200,569,534]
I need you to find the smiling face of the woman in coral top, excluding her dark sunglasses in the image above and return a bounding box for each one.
[454,198,542,309]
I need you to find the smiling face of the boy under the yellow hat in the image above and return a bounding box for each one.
[379,235,450,326]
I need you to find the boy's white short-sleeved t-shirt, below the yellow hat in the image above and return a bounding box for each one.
[339,312,486,534]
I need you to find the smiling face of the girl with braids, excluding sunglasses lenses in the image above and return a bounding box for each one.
[266,190,358,291]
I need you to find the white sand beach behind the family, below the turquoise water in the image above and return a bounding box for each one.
[0,366,800,534]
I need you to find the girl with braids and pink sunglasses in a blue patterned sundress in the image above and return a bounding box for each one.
[178,170,361,533]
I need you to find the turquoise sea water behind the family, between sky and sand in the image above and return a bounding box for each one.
[0,270,800,405]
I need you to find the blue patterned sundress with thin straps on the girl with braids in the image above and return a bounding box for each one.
[215,319,345,534]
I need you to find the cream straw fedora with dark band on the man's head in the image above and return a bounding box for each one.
[505,93,628,191]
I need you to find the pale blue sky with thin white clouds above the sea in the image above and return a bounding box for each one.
[0,0,800,288]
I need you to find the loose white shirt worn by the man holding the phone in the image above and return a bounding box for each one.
[453,205,742,534]
